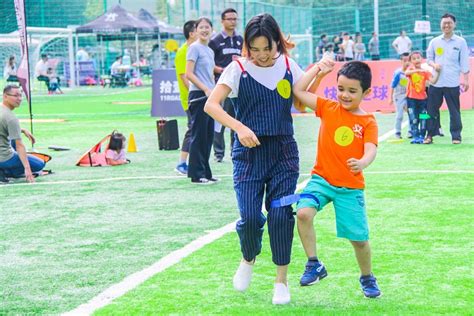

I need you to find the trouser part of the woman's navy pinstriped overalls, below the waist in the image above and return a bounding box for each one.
[232,136,299,265]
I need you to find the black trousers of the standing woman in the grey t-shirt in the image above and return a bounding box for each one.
[188,91,214,179]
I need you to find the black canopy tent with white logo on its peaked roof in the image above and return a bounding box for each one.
[76,5,160,77]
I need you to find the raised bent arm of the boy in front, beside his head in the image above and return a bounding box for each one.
[293,58,334,110]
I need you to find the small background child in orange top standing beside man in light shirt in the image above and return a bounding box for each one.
[405,51,440,144]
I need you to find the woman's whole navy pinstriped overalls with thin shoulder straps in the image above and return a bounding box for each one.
[232,57,299,265]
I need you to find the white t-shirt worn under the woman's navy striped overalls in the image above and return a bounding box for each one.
[217,55,304,98]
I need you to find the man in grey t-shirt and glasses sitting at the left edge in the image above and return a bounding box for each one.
[0,85,45,183]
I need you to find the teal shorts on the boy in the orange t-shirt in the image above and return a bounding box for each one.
[296,175,369,241]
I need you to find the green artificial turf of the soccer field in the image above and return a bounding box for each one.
[0,88,474,315]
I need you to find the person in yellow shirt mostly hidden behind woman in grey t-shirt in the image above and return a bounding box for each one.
[174,20,196,175]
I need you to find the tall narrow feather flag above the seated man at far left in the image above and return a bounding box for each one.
[15,0,30,101]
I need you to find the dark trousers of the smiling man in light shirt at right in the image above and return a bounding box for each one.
[427,86,462,140]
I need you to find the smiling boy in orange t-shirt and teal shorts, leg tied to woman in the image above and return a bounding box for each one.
[294,58,381,298]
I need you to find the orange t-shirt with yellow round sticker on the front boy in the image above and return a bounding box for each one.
[311,97,378,189]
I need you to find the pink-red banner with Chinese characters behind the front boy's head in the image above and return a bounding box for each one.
[317,57,474,112]
